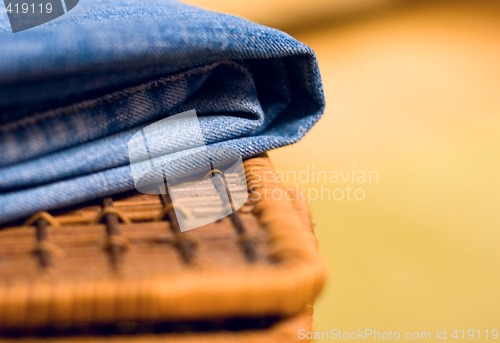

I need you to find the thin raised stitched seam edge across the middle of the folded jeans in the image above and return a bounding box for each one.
[0,61,248,132]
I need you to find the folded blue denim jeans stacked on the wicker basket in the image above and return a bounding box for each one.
[0,0,324,222]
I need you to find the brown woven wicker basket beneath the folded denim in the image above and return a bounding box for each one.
[0,156,326,342]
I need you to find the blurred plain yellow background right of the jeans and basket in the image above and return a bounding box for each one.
[187,0,500,341]
